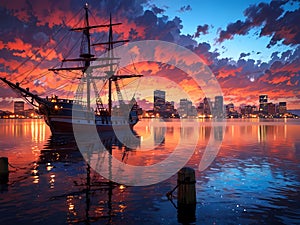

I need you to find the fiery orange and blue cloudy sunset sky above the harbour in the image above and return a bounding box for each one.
[0,0,300,109]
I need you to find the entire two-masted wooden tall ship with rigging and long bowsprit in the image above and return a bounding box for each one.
[0,4,142,135]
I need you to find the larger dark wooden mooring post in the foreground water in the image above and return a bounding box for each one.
[177,167,196,224]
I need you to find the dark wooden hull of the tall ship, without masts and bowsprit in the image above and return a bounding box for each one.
[39,96,138,135]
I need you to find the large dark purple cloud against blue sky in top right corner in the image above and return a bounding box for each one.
[217,0,300,47]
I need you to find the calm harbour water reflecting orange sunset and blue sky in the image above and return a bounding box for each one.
[0,120,300,224]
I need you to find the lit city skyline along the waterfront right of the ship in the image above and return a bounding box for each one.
[143,90,298,118]
